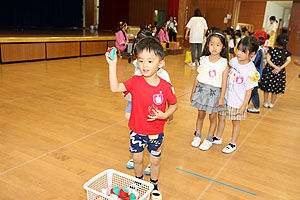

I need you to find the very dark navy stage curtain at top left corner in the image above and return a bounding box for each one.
[0,0,83,27]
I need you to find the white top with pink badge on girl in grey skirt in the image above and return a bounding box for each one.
[197,56,228,88]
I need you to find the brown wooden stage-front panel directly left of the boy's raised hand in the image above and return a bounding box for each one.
[81,41,107,56]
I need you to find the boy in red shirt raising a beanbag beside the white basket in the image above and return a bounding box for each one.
[106,37,177,199]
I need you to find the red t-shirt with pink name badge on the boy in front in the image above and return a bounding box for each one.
[124,76,177,135]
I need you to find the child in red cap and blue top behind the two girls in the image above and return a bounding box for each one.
[247,31,267,113]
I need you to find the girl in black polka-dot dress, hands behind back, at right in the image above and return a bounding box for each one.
[261,34,292,108]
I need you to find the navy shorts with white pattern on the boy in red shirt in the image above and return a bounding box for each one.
[129,131,164,157]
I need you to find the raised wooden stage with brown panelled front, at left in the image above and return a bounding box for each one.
[0,28,133,63]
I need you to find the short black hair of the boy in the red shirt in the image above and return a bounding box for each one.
[134,37,165,60]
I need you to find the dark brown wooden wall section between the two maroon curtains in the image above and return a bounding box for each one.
[128,0,169,27]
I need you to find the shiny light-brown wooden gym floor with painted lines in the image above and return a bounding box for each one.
[0,55,300,200]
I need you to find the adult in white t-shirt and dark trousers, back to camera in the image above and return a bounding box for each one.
[185,8,208,66]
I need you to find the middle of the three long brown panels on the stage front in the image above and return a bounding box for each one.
[46,42,80,59]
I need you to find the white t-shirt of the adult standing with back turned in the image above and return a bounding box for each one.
[186,17,208,43]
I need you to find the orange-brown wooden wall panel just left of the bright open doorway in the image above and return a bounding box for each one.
[238,1,266,32]
